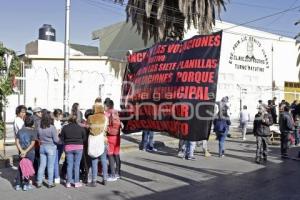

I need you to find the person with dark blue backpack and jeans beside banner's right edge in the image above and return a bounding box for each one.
[213,111,231,158]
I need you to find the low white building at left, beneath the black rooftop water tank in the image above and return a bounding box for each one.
[6,40,125,122]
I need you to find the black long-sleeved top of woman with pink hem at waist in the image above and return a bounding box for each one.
[60,123,86,145]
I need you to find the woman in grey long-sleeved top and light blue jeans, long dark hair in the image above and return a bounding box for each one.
[37,109,59,188]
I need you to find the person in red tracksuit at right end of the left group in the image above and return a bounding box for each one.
[105,100,121,181]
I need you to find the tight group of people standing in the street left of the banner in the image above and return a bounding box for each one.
[14,98,121,191]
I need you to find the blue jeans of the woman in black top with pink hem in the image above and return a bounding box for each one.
[66,149,82,183]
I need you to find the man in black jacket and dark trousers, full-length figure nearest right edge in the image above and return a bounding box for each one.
[279,106,294,158]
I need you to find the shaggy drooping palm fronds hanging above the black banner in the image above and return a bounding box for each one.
[115,0,229,43]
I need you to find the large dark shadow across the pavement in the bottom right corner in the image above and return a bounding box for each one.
[120,153,300,200]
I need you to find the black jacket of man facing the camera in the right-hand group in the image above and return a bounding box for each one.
[253,113,273,137]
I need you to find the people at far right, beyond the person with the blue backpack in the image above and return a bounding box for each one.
[240,97,300,164]
